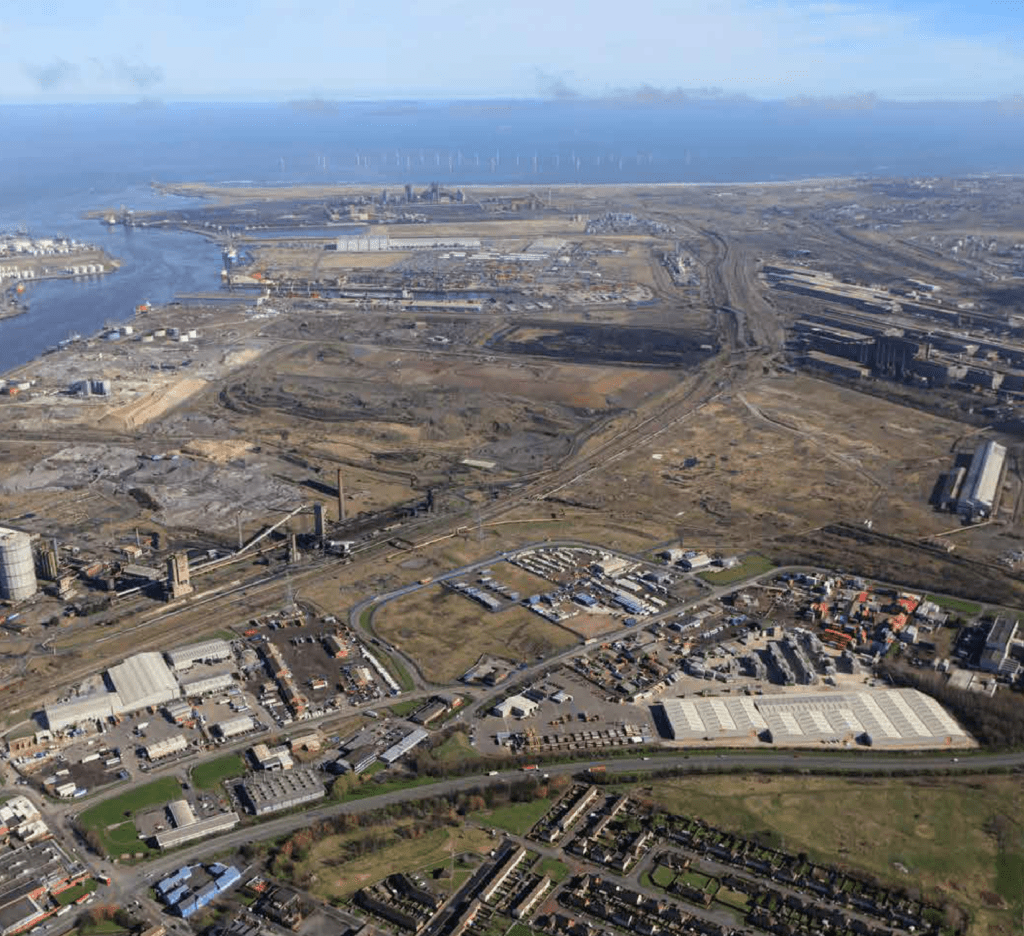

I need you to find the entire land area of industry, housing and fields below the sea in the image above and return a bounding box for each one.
[0,178,1024,936]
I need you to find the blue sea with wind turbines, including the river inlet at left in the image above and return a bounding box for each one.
[0,99,1024,373]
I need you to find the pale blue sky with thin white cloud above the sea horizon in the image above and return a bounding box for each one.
[0,0,1024,101]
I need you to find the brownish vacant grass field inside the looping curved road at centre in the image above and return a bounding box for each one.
[374,585,577,683]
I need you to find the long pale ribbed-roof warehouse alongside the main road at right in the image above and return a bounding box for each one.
[659,689,971,748]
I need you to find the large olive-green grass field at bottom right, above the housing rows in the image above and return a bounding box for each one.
[652,776,1024,936]
